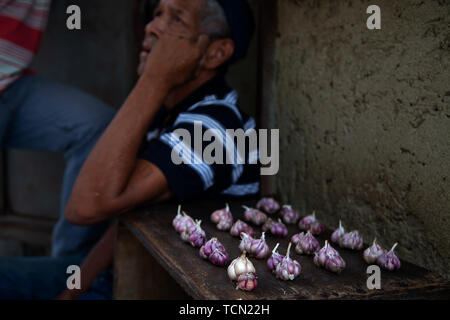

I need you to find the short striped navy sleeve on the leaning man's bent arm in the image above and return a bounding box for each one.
[140,106,243,200]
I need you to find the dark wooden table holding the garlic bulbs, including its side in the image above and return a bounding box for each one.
[115,200,450,300]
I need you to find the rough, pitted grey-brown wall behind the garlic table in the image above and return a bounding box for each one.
[275,0,450,278]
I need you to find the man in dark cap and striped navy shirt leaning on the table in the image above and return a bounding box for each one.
[3,0,259,299]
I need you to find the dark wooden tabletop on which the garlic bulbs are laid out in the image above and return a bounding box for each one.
[121,201,450,300]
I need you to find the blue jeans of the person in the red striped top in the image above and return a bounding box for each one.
[0,75,114,298]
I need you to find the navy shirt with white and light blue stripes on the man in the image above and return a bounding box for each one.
[139,76,260,200]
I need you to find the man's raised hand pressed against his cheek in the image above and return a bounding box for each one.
[143,33,209,90]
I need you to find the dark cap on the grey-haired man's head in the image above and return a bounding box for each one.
[217,0,255,62]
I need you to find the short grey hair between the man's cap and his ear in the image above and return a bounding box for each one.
[199,0,231,38]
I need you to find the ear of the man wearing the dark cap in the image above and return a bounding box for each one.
[201,38,234,70]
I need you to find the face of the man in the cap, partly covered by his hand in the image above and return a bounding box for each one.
[138,0,205,76]
